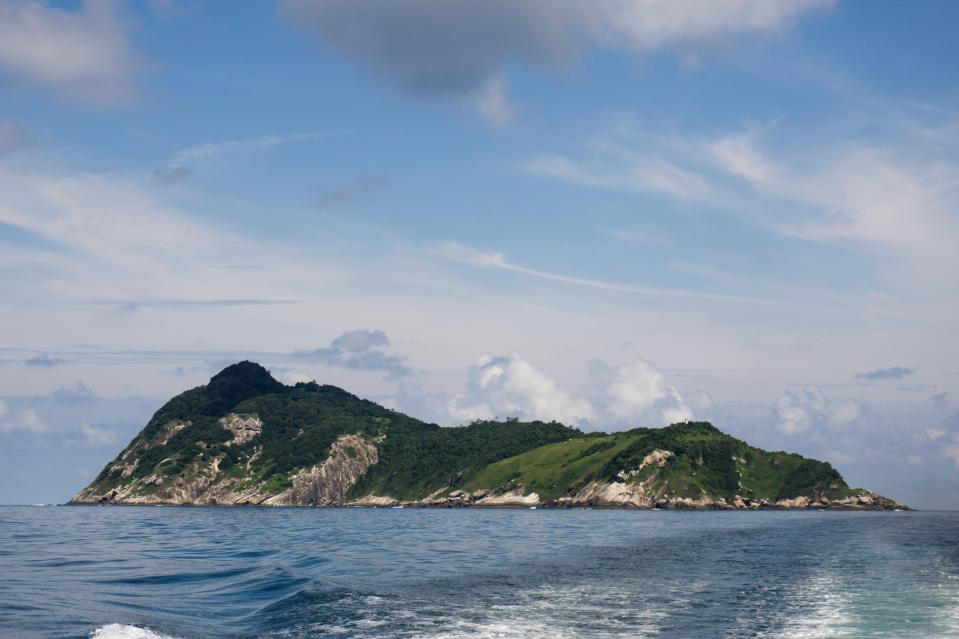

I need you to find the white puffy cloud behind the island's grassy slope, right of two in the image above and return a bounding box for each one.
[590,359,692,426]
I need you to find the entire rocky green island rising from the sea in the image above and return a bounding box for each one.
[69,361,907,510]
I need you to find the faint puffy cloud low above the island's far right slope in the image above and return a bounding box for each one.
[773,386,867,435]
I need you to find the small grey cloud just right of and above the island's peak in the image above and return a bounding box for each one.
[293,329,413,379]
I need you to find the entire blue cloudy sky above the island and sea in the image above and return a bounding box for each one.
[0,0,959,509]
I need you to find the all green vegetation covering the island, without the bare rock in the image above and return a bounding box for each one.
[84,362,849,508]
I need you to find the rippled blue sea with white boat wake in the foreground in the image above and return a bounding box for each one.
[0,507,959,639]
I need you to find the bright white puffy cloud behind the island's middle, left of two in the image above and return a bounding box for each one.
[447,353,594,424]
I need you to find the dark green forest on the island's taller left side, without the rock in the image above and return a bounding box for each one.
[96,362,583,498]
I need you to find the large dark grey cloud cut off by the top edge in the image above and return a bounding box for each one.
[280,0,832,97]
